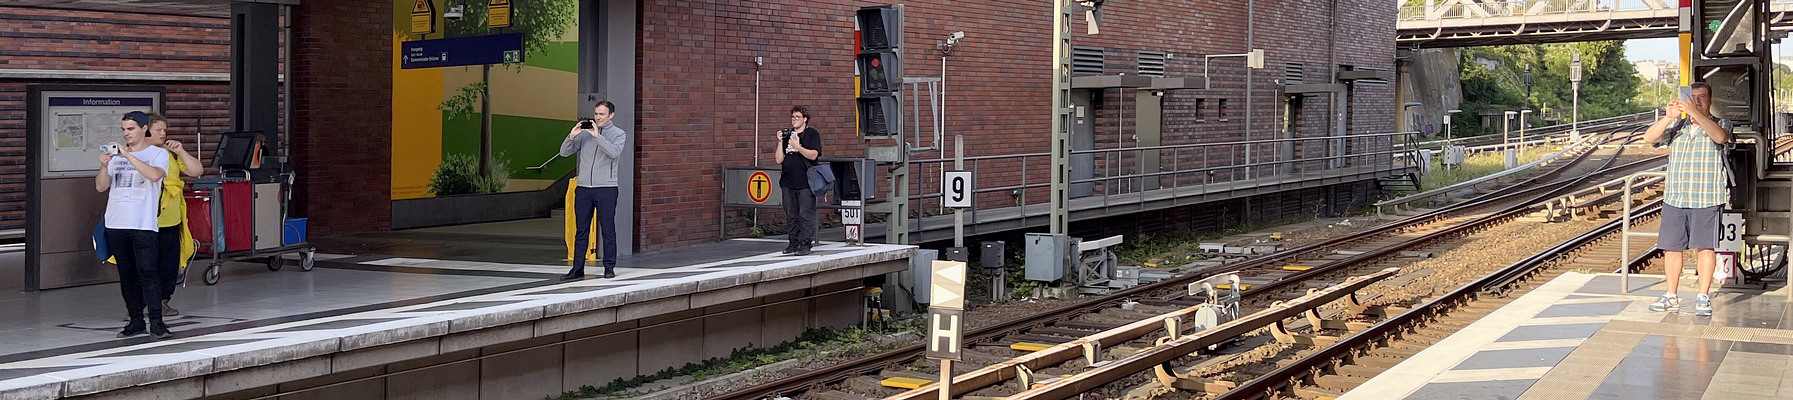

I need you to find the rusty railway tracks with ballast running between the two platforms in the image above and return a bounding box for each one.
[717,126,1660,400]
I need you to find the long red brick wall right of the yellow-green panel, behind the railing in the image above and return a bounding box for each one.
[637,0,1395,251]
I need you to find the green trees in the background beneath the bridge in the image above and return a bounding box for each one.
[1456,41,1653,133]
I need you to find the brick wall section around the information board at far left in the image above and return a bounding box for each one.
[0,7,230,230]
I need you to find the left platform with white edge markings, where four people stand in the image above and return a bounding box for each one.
[0,233,914,398]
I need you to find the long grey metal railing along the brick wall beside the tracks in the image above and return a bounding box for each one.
[909,133,1418,228]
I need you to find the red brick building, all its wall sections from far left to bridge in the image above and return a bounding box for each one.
[14,0,1397,251]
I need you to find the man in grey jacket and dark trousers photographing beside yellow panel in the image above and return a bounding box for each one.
[559,100,628,280]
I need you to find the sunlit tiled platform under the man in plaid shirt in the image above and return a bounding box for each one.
[1339,273,1793,400]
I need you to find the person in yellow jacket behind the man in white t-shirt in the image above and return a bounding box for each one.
[149,113,204,316]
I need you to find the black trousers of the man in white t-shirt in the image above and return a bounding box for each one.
[106,228,161,321]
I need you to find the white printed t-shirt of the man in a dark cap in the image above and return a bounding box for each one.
[106,145,169,231]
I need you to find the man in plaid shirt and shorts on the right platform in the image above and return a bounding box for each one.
[1644,83,1730,316]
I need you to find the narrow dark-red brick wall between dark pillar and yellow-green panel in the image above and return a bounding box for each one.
[292,0,393,235]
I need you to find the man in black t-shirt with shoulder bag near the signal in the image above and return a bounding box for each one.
[773,106,821,255]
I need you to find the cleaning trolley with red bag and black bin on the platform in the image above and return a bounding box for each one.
[181,133,317,285]
